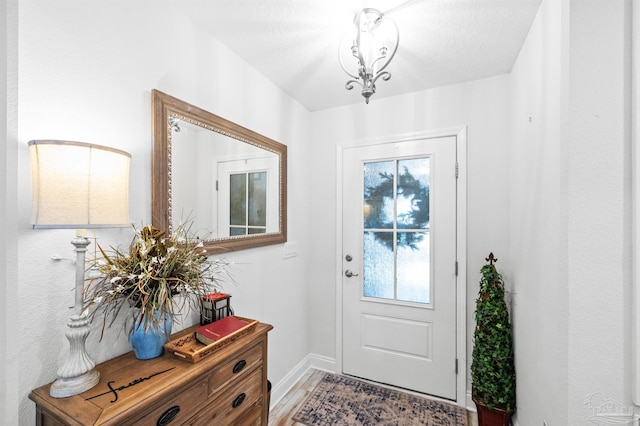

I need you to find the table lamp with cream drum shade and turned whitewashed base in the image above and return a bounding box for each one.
[29,140,131,398]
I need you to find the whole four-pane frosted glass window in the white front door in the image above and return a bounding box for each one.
[363,157,431,304]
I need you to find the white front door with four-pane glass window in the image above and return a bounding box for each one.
[342,136,457,400]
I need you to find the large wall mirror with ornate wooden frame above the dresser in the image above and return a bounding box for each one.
[151,89,287,254]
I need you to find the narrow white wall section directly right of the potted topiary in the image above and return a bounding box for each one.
[509,0,570,425]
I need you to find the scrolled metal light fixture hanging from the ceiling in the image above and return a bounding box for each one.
[339,8,400,103]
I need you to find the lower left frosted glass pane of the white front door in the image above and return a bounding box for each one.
[363,232,394,299]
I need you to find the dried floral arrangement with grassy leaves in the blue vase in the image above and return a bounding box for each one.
[85,223,229,338]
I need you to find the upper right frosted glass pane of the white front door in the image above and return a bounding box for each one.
[397,158,429,229]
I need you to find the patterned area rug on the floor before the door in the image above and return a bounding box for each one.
[293,373,467,426]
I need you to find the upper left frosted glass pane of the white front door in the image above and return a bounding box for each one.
[364,161,395,229]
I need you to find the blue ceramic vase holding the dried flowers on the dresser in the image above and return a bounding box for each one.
[129,314,172,359]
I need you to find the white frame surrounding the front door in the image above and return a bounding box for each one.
[335,126,467,407]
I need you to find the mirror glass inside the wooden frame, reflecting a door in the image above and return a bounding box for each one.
[171,119,278,239]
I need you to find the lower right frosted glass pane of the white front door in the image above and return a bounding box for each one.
[397,232,431,303]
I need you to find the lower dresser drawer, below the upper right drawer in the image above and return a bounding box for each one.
[185,368,265,426]
